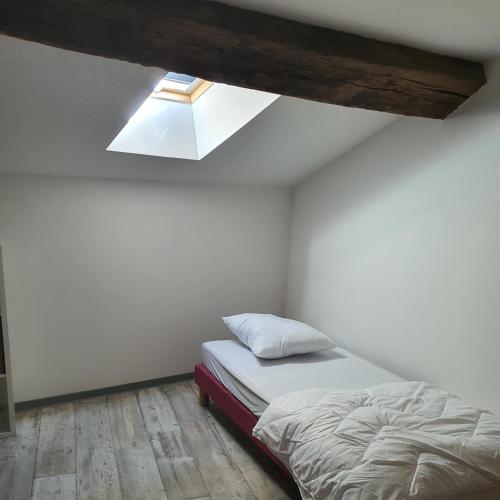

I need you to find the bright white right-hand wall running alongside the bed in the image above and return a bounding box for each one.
[287,54,500,412]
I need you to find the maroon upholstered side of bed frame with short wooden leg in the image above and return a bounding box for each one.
[194,363,293,481]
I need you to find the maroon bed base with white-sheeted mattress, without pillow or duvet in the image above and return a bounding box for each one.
[195,340,403,477]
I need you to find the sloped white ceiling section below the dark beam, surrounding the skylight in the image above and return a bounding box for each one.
[0,36,395,185]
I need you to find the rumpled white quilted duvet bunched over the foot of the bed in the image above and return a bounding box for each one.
[254,382,500,500]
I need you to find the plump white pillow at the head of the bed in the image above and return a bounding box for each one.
[222,314,335,359]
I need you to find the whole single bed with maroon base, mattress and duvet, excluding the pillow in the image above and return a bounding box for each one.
[195,340,500,500]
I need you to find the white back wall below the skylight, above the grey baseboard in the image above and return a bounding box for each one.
[0,175,290,401]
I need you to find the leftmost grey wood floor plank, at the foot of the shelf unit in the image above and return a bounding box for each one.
[0,409,40,500]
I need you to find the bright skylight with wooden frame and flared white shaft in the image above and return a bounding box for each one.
[107,73,279,160]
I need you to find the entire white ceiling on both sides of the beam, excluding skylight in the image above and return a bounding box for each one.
[0,0,500,186]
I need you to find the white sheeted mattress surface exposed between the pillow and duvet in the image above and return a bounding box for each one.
[201,340,404,416]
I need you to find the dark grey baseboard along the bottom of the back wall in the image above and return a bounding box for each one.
[15,372,194,410]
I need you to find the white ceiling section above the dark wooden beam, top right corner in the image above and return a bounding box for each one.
[222,0,500,60]
